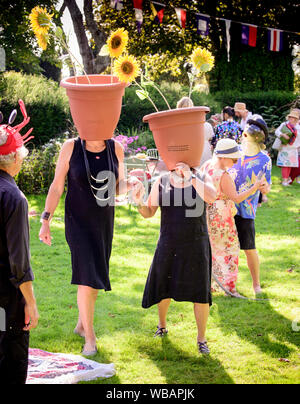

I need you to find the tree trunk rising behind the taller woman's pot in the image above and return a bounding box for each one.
[65,0,109,74]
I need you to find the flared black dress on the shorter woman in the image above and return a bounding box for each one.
[142,175,212,309]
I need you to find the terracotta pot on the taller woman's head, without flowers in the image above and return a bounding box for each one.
[60,74,126,140]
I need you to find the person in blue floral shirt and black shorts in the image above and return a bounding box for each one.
[230,118,272,294]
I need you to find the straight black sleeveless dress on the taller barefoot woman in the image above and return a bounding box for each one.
[65,138,118,291]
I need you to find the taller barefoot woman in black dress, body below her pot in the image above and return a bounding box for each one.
[39,137,138,356]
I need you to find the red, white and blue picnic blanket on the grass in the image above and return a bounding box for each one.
[26,349,116,384]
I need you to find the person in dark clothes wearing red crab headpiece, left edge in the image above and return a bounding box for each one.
[0,104,39,384]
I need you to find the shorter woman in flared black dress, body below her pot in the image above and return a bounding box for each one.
[133,158,216,354]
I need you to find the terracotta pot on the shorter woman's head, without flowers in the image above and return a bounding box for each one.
[143,107,209,171]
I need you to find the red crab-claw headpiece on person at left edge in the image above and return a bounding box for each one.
[0,100,34,156]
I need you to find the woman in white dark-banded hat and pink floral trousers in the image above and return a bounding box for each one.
[201,138,260,297]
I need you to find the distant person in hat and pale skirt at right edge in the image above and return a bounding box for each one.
[275,108,300,186]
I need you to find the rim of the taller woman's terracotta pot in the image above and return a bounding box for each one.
[60,74,127,91]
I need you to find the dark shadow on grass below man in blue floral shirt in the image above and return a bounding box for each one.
[214,296,300,358]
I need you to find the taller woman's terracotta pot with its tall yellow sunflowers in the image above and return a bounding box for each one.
[30,6,138,140]
